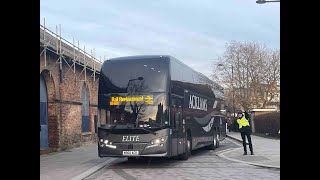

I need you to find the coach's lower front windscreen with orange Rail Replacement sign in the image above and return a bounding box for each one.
[107,93,169,128]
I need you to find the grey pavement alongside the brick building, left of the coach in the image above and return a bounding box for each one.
[40,143,116,180]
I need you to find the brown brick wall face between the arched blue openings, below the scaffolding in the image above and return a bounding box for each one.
[40,48,98,149]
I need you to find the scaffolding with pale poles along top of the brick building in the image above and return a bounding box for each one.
[40,19,102,83]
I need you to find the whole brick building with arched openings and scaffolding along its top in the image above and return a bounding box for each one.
[40,22,101,153]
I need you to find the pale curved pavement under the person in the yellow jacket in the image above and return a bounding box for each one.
[217,132,280,169]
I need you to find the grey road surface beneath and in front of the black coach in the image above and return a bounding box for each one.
[85,139,280,180]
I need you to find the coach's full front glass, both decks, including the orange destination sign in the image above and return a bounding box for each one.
[98,59,169,128]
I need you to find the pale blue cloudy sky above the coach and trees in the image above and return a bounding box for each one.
[40,0,280,77]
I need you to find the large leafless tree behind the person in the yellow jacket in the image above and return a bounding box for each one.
[212,41,280,109]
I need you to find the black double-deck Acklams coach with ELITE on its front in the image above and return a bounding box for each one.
[98,55,226,160]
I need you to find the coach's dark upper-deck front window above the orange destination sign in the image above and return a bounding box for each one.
[100,59,168,93]
